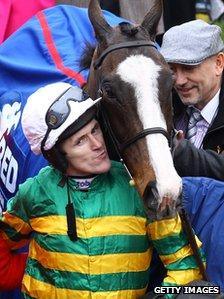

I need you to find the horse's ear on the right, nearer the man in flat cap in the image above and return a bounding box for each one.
[141,0,163,40]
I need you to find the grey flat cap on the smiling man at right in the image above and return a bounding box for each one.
[161,20,224,65]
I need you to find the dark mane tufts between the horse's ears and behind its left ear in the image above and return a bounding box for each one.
[80,22,139,70]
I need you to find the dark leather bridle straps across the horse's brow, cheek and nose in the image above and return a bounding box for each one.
[93,40,170,161]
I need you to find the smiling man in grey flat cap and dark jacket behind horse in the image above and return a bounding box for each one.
[161,20,224,180]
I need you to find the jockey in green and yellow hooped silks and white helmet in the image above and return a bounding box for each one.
[0,82,203,298]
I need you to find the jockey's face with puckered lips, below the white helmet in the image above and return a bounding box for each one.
[61,119,111,176]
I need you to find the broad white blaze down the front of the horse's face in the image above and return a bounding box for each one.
[117,55,182,200]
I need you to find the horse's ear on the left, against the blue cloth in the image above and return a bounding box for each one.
[88,0,112,41]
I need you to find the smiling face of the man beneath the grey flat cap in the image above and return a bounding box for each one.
[170,54,223,110]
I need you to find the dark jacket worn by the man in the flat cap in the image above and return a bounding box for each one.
[173,77,224,180]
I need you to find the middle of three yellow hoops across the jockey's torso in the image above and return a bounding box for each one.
[29,240,152,275]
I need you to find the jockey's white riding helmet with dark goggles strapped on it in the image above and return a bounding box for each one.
[21,82,101,154]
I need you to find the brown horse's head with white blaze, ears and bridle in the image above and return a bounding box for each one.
[88,0,181,206]
